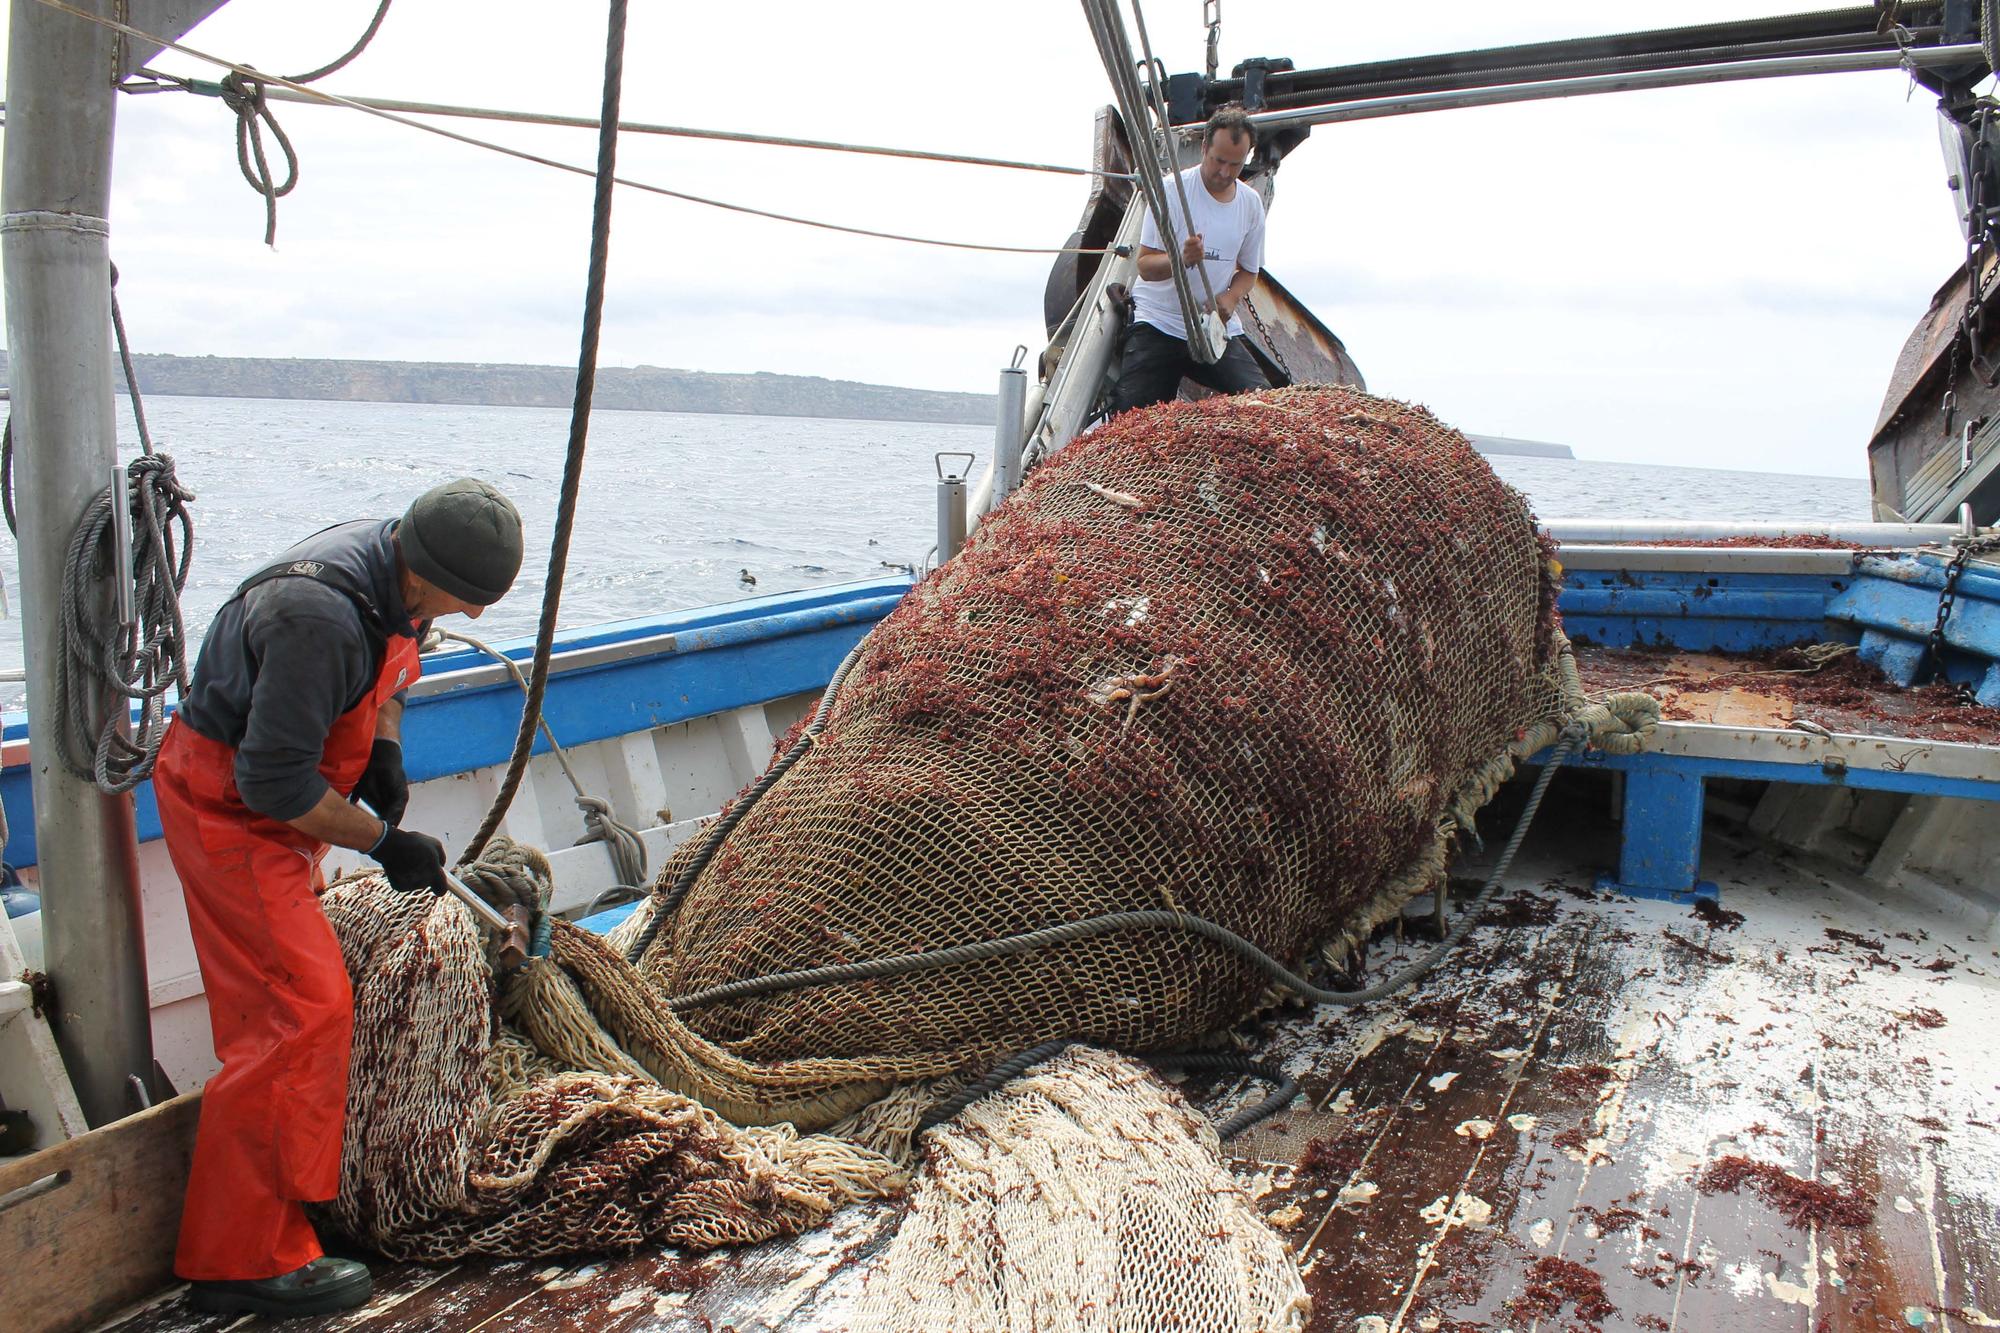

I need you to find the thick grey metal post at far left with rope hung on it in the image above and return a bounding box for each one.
[0,0,152,1125]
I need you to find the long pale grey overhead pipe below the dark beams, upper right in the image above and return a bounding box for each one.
[1240,42,1986,132]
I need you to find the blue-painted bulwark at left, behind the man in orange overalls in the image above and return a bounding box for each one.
[0,576,910,867]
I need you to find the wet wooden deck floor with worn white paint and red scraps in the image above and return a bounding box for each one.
[86,788,2000,1333]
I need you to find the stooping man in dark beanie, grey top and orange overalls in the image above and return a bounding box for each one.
[152,478,522,1315]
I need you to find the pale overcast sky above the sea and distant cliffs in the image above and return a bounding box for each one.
[0,0,1962,476]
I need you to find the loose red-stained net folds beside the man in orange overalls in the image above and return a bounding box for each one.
[320,839,900,1259]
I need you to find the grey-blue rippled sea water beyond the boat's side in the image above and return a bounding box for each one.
[0,396,1868,709]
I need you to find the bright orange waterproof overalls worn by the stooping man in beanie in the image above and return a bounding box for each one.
[152,584,420,1281]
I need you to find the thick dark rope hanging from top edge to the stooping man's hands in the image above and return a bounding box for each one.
[458,0,626,865]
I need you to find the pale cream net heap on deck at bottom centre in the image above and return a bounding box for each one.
[852,1047,1310,1333]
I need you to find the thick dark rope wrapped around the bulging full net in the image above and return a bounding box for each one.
[664,720,1590,1013]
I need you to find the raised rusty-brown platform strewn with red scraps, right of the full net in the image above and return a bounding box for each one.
[1576,644,2000,745]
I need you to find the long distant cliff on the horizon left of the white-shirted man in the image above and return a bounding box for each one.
[0,352,994,426]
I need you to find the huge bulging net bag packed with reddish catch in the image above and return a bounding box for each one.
[624,388,1574,1127]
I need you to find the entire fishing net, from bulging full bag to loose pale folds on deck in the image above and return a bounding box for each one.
[326,388,1608,1296]
